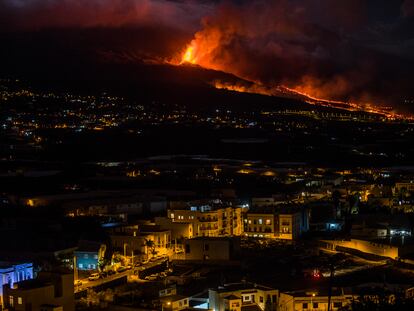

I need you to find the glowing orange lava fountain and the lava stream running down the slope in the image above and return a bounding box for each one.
[178,41,414,120]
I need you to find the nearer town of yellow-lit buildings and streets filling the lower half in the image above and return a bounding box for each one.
[0,157,414,310]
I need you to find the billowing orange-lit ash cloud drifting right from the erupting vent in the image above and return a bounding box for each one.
[187,0,414,108]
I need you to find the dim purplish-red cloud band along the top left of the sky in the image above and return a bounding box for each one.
[0,0,209,30]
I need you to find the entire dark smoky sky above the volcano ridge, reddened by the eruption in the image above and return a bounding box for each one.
[0,0,414,110]
